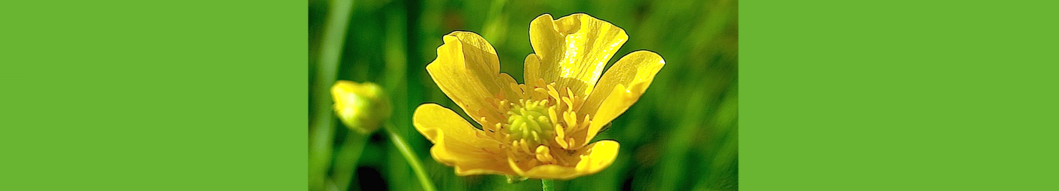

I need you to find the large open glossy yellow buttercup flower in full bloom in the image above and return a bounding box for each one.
[412,14,665,179]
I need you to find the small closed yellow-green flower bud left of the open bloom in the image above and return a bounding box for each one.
[331,81,391,134]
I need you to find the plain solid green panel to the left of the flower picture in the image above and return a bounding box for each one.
[13,0,308,191]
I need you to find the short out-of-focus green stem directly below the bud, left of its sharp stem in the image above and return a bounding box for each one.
[331,131,369,190]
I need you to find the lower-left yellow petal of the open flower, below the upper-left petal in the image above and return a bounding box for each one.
[412,104,515,175]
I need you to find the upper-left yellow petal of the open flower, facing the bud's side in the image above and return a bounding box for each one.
[427,31,510,125]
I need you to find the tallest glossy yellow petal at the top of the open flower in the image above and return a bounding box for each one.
[530,14,628,98]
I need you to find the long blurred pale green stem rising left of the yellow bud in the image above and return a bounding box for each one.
[309,0,353,190]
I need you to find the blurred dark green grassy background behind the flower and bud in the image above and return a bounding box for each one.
[308,0,738,190]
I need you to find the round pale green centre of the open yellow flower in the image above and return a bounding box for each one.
[504,100,555,146]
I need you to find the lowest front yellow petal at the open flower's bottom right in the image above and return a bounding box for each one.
[523,140,618,179]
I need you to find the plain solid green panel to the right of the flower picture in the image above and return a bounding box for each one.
[739,1,1059,190]
